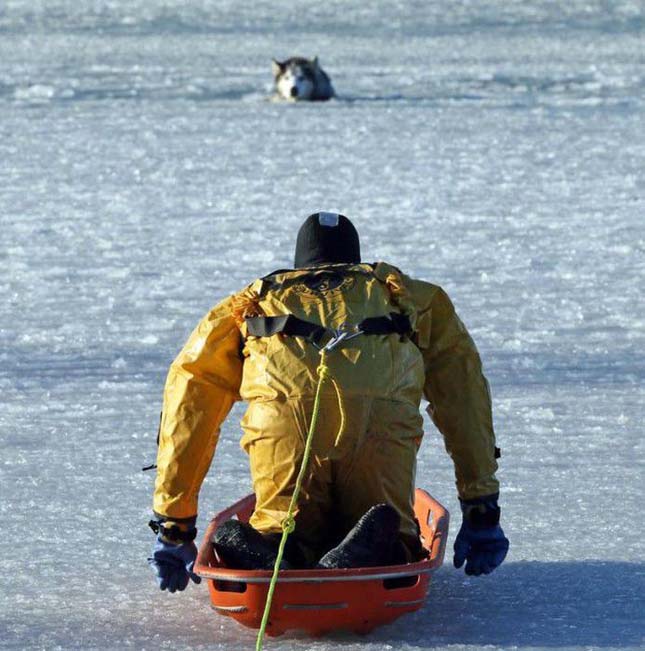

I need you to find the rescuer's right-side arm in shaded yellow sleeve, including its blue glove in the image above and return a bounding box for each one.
[417,287,509,576]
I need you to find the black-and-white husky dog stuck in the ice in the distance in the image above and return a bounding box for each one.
[272,57,335,102]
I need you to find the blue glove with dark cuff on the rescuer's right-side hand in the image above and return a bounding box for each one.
[453,495,509,576]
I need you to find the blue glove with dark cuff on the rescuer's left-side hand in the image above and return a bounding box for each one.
[148,520,201,592]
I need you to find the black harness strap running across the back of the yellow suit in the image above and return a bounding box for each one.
[245,312,412,342]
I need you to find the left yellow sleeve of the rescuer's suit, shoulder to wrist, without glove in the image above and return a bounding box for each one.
[153,298,242,527]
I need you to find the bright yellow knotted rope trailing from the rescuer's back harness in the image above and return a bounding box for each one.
[255,350,338,651]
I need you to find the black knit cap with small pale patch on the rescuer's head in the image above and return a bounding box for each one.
[295,212,361,269]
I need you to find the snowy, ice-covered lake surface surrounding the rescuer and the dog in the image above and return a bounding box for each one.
[0,0,645,651]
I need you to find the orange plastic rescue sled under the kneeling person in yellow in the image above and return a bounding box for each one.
[195,488,449,636]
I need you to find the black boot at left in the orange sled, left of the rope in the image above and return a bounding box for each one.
[211,520,291,570]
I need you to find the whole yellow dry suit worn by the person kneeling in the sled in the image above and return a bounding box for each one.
[154,263,498,558]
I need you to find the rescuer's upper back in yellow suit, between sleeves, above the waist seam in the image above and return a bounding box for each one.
[235,263,425,406]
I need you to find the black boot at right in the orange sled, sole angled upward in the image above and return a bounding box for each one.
[318,504,401,570]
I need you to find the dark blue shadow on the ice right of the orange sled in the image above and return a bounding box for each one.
[358,561,645,649]
